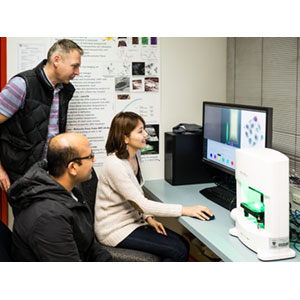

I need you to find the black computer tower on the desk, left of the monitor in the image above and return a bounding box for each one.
[165,132,213,185]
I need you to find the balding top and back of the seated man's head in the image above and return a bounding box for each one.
[47,132,89,177]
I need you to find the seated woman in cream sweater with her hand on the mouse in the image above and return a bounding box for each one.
[95,112,212,261]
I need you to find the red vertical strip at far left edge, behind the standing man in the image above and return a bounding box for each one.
[0,37,8,225]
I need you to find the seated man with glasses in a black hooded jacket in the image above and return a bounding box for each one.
[7,133,111,261]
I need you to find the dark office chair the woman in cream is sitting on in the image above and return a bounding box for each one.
[77,169,161,262]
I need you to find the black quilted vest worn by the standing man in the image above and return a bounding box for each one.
[0,60,75,183]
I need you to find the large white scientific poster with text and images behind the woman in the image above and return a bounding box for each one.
[51,37,160,171]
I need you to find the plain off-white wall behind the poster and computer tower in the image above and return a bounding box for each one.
[7,37,227,226]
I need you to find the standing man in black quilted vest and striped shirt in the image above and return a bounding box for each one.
[0,39,83,191]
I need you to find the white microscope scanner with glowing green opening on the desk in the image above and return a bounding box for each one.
[229,148,296,261]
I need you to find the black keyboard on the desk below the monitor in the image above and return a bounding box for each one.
[199,186,236,210]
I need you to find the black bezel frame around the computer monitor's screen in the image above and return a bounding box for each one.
[202,101,273,176]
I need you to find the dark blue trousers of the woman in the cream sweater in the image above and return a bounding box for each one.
[117,226,189,261]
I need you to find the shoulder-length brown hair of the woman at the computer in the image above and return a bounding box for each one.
[105,111,145,159]
